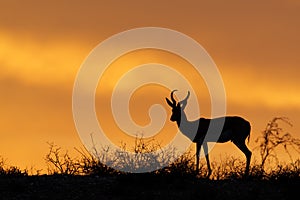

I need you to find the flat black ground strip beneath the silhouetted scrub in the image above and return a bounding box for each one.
[0,174,300,200]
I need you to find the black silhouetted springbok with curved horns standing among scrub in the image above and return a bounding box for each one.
[166,90,252,177]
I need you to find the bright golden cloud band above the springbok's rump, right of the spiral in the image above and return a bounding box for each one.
[222,65,300,109]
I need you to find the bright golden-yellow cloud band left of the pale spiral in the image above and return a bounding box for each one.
[0,32,89,84]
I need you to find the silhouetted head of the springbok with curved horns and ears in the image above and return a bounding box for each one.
[166,90,190,124]
